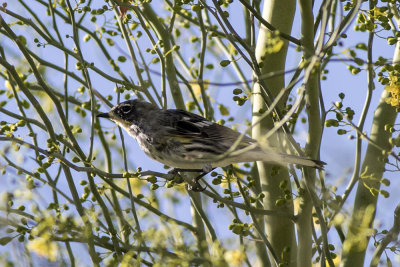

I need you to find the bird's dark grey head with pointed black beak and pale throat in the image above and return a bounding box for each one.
[97,99,158,128]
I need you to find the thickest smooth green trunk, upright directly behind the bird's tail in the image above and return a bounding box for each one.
[252,0,296,266]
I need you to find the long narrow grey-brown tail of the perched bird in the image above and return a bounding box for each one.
[241,149,326,170]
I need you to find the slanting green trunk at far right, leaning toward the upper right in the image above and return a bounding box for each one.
[342,43,400,267]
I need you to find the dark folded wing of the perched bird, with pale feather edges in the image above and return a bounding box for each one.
[162,109,255,149]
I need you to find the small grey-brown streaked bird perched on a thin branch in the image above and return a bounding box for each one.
[97,99,326,191]
